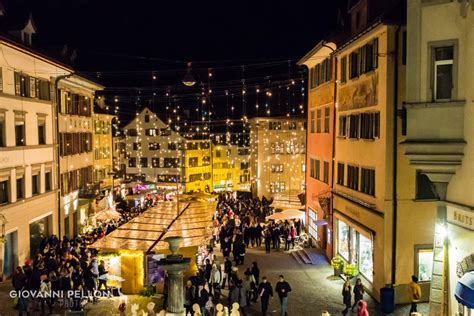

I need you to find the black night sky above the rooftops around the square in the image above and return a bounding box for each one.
[3,0,344,130]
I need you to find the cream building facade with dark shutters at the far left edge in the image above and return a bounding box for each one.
[0,33,71,277]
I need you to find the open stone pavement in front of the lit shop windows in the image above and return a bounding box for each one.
[216,248,428,316]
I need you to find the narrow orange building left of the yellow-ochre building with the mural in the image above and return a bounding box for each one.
[298,40,336,257]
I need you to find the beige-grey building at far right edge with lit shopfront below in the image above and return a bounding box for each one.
[403,0,474,315]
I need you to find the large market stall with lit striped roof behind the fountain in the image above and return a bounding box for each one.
[90,200,216,294]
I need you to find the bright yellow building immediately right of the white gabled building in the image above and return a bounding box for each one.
[182,140,212,192]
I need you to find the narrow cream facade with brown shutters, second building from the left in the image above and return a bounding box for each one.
[57,75,104,237]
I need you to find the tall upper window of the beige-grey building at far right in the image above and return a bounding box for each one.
[434,46,454,101]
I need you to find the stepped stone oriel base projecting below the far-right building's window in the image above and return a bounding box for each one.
[402,101,466,191]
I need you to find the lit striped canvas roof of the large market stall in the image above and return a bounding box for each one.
[90,201,216,252]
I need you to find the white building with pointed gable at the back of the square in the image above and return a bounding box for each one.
[119,108,184,189]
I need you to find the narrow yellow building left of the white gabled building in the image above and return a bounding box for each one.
[93,109,115,190]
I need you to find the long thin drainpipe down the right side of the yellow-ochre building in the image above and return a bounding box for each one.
[391,24,402,286]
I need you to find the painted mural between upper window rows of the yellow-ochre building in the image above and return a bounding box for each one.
[337,73,379,112]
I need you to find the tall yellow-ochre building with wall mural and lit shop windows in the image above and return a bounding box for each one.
[332,1,434,303]
